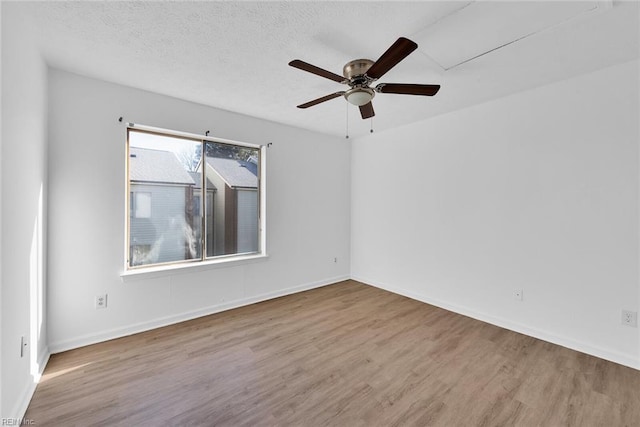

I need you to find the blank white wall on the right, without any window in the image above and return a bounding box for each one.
[351,61,640,368]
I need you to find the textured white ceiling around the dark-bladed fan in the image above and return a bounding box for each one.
[11,1,640,136]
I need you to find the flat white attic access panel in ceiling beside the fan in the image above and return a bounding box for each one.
[413,0,612,70]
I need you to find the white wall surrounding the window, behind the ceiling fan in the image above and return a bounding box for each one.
[48,70,350,352]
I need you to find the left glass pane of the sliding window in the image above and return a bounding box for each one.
[129,130,202,267]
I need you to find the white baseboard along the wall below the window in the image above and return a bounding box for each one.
[49,275,349,354]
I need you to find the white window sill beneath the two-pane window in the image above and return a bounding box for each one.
[120,254,269,282]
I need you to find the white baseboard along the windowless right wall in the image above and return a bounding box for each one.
[351,276,640,370]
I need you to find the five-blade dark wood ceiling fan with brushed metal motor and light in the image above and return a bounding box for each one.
[289,37,440,119]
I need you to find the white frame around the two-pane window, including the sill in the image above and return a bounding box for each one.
[120,123,268,280]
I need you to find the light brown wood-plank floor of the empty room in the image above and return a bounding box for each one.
[26,281,640,427]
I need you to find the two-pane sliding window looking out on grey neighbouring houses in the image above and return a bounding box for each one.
[126,126,264,269]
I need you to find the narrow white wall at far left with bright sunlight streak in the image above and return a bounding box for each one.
[0,2,48,418]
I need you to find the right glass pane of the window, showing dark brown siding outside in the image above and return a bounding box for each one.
[205,142,260,256]
